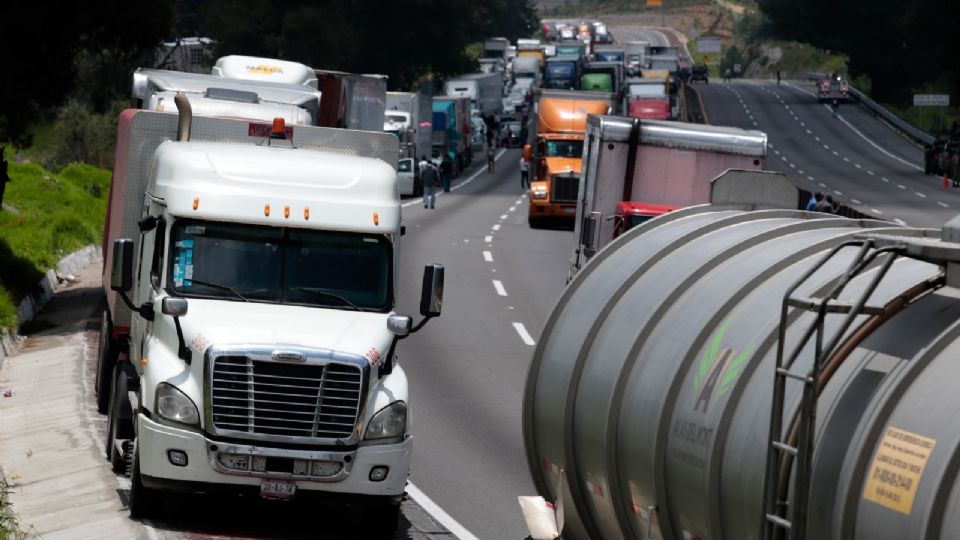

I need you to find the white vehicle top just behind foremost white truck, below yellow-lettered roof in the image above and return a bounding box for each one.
[132,68,321,126]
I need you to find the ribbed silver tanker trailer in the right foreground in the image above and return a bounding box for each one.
[523,171,960,540]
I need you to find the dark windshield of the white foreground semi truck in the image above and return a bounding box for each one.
[168,220,393,312]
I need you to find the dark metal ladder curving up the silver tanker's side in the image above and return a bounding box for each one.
[763,238,904,540]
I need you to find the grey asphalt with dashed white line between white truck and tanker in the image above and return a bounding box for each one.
[398,150,573,539]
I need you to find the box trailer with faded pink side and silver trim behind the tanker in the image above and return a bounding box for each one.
[570,115,767,276]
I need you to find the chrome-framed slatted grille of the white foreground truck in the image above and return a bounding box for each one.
[207,353,365,443]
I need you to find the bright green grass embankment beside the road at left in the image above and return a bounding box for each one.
[0,153,110,328]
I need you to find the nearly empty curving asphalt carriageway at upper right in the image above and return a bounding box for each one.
[697,80,960,228]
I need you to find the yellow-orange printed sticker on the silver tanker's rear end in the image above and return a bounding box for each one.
[863,427,937,515]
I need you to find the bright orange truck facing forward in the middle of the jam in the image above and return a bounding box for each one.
[523,90,617,227]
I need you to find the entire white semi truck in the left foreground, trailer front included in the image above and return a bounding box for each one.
[97,95,443,534]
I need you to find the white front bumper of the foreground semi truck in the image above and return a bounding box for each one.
[137,414,413,496]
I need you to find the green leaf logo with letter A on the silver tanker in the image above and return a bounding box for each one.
[693,319,754,414]
